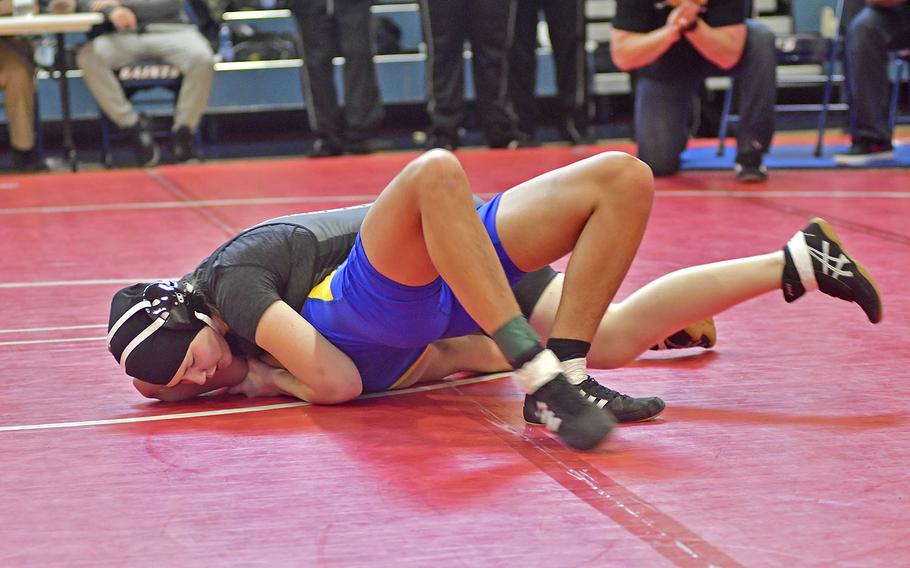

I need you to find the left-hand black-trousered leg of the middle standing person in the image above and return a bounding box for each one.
[420,0,470,149]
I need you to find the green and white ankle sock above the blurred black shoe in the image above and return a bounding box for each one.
[490,316,561,394]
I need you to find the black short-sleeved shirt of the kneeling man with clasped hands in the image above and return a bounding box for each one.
[613,0,746,80]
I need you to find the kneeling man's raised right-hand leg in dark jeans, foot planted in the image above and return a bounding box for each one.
[731,20,777,165]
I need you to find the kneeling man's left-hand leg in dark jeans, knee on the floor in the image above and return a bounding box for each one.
[635,75,703,176]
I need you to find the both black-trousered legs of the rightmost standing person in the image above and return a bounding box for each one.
[509,0,593,145]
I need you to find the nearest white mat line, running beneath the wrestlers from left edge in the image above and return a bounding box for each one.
[0,373,511,432]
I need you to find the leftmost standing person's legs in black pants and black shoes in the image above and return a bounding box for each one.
[290,0,384,158]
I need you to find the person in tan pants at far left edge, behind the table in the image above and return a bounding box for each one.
[0,0,46,172]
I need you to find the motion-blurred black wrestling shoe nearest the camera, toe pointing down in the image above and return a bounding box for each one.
[524,374,616,450]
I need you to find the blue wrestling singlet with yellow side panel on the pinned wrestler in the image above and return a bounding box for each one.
[301,195,525,392]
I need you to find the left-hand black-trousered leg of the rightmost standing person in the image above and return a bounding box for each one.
[509,0,540,138]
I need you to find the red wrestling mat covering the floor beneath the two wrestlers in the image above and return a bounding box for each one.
[0,145,910,567]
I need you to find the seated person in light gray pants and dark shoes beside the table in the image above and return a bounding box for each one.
[50,0,215,166]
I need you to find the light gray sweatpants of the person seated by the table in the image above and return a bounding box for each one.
[76,24,215,131]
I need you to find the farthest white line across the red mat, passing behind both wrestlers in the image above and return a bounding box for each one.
[0,189,910,215]
